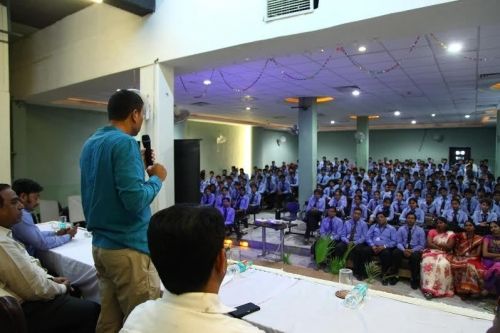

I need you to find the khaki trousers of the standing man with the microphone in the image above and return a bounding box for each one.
[92,247,160,333]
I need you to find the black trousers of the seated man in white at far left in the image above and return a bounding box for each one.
[22,295,101,333]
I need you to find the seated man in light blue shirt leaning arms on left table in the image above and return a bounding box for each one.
[12,179,78,256]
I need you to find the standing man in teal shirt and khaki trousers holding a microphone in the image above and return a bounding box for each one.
[80,90,167,333]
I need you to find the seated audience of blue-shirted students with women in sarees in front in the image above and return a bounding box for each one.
[200,156,500,298]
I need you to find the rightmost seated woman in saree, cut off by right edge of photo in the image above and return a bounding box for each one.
[483,221,500,296]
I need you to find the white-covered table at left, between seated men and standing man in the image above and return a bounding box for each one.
[37,222,100,303]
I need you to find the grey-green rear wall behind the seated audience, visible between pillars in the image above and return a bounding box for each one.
[249,127,496,167]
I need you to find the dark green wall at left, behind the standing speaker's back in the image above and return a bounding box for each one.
[12,105,107,205]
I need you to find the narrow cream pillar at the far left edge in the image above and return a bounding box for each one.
[0,5,11,184]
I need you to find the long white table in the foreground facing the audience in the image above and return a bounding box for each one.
[220,267,493,333]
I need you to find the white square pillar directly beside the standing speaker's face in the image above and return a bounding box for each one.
[138,64,175,212]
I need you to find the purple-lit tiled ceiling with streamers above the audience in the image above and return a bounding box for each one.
[175,25,500,128]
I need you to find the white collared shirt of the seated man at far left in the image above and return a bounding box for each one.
[0,226,66,302]
